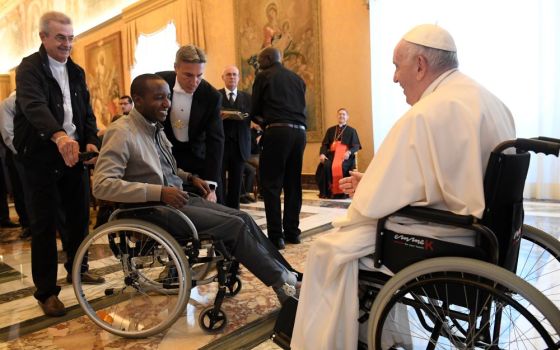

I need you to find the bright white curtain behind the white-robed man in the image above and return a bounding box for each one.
[370,0,560,200]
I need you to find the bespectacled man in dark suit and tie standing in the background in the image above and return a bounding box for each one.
[219,66,251,209]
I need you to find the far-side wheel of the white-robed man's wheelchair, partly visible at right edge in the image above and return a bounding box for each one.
[516,225,560,308]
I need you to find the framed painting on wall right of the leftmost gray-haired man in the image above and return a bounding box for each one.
[85,32,124,130]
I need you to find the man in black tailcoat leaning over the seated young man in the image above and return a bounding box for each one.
[157,45,224,202]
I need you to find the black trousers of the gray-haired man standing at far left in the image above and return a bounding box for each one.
[24,159,89,301]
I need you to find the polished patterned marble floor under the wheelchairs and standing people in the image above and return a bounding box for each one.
[0,196,560,350]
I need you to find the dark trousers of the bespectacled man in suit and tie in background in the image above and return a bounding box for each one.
[222,143,245,209]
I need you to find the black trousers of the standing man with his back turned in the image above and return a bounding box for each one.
[259,127,306,239]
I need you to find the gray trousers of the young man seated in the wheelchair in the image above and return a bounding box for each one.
[180,197,295,287]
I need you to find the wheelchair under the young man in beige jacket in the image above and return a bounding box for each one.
[72,203,242,338]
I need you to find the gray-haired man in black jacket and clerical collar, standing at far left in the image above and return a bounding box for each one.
[13,12,104,316]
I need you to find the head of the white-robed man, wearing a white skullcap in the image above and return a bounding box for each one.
[393,25,459,106]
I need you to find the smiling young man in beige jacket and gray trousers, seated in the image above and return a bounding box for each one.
[93,74,298,301]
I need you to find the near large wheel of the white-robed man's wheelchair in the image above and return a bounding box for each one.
[368,257,560,349]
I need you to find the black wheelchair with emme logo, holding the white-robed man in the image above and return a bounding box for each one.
[273,137,560,349]
